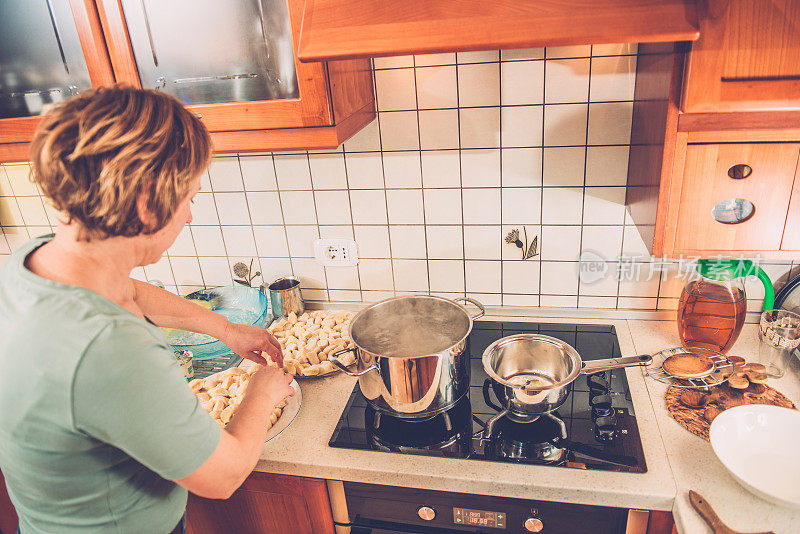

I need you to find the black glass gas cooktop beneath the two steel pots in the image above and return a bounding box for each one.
[329,321,647,473]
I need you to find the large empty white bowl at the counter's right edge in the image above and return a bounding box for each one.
[710,404,800,508]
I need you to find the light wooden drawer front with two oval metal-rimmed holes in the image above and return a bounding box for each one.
[674,143,800,253]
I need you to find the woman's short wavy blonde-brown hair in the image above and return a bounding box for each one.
[31,86,212,241]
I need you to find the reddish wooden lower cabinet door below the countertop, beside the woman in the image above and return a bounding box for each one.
[186,472,334,534]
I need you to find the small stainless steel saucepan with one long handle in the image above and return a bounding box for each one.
[482,334,653,416]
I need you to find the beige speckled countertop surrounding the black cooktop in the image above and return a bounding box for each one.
[250,315,800,534]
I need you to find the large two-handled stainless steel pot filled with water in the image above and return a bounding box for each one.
[329,295,484,419]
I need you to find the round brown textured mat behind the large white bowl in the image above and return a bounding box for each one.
[664,384,797,441]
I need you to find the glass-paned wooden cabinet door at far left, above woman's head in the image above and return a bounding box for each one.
[0,0,114,147]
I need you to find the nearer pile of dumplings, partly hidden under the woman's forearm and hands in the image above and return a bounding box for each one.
[189,365,286,428]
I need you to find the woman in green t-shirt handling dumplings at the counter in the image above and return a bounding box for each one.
[0,87,293,534]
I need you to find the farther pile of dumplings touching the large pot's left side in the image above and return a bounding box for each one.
[264,311,356,376]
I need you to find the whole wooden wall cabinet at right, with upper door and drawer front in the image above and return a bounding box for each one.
[626,0,800,260]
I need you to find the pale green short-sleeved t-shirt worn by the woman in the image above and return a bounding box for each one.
[0,239,220,534]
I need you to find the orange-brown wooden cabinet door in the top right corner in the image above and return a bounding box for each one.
[682,0,800,112]
